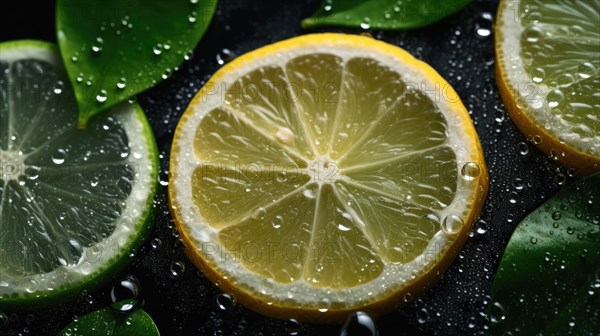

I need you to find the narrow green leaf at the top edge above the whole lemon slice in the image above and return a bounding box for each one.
[302,0,471,30]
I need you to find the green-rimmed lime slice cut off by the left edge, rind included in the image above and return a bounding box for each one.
[0,41,158,309]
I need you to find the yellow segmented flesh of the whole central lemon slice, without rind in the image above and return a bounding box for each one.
[192,54,458,288]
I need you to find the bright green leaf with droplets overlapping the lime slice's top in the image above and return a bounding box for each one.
[56,0,217,127]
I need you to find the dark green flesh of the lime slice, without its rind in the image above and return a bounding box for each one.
[0,59,136,277]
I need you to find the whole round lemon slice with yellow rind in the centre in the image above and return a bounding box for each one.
[169,34,487,322]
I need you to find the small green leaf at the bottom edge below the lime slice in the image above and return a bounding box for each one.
[58,302,160,336]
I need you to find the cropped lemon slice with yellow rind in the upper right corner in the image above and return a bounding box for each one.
[496,0,600,175]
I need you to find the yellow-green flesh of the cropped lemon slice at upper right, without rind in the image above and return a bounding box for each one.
[518,0,600,147]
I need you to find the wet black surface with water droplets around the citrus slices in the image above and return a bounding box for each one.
[0,0,572,336]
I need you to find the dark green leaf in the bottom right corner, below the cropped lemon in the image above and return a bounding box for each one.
[489,173,600,335]
